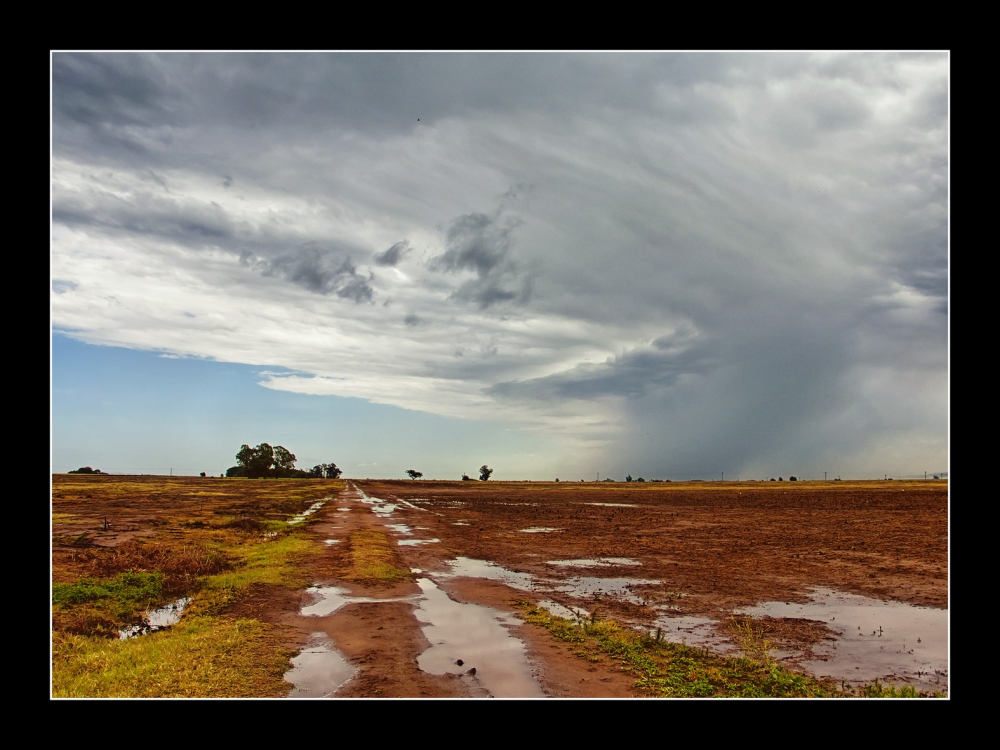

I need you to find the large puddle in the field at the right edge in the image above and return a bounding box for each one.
[740,588,948,690]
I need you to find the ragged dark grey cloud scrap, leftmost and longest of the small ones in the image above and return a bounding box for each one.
[246,243,375,304]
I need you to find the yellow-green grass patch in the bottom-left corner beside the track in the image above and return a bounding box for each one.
[52,617,293,698]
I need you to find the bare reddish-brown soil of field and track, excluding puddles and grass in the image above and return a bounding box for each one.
[53,475,948,697]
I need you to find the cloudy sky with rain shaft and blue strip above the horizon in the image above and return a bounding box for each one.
[50,52,950,481]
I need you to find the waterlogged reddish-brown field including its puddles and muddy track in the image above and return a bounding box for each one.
[53,478,949,698]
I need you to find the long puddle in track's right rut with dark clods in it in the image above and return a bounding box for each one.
[415,578,545,698]
